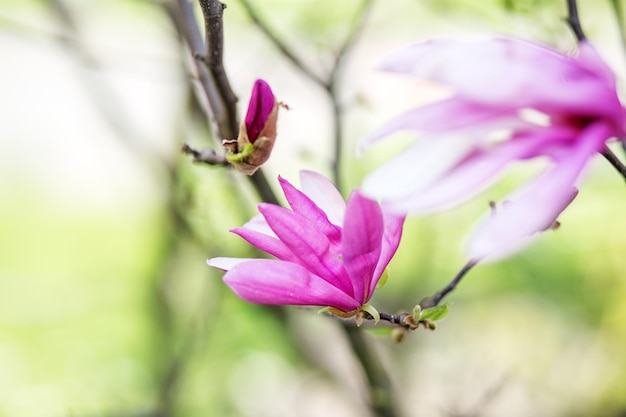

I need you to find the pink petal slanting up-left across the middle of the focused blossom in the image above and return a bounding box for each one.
[259,204,353,296]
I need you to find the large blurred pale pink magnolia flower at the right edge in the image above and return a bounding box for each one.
[361,38,625,260]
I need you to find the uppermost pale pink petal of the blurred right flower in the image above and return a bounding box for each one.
[381,38,620,122]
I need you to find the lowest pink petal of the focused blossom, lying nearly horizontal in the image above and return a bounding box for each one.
[224,259,360,311]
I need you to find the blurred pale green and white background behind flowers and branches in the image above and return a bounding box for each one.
[0,0,626,417]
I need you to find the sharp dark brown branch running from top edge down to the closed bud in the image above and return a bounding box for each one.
[199,0,239,139]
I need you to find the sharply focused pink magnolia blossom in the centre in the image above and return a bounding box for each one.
[207,171,404,312]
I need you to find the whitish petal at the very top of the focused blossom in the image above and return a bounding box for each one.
[300,170,346,227]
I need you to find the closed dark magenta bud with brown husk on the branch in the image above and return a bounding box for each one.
[223,80,282,175]
